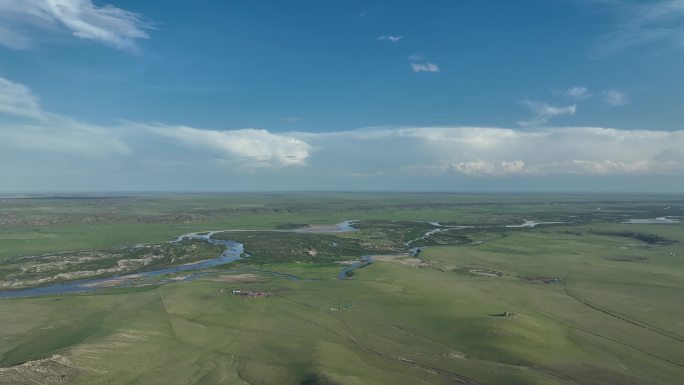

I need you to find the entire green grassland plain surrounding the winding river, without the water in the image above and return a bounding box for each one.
[0,193,684,385]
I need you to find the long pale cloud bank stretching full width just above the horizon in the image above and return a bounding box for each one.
[0,79,684,191]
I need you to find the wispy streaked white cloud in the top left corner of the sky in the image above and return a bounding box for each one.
[0,0,152,50]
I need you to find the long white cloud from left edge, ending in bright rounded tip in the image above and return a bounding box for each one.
[0,78,311,166]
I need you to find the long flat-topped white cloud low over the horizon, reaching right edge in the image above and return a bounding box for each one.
[292,127,684,178]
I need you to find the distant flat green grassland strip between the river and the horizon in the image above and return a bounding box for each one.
[0,193,684,258]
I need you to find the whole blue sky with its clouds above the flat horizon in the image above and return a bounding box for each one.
[0,0,684,193]
